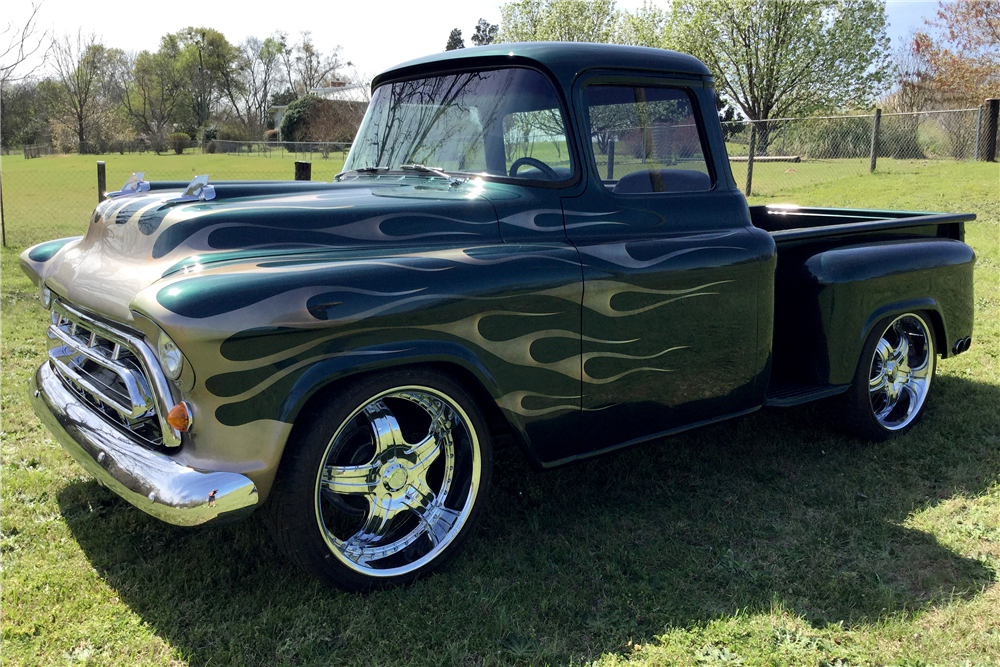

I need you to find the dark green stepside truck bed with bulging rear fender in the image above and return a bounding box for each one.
[750,205,976,406]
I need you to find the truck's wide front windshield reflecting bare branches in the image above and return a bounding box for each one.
[344,68,573,181]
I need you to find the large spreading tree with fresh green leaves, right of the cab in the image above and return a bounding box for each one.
[673,0,892,148]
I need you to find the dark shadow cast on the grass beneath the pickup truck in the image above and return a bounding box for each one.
[59,377,1000,665]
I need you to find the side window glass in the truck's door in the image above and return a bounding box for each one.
[584,85,713,194]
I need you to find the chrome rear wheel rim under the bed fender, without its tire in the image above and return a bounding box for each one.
[868,314,934,431]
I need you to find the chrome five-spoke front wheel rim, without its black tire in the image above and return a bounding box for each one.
[314,386,482,577]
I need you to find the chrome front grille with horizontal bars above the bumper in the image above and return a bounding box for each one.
[48,302,173,447]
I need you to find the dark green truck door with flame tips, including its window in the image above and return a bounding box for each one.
[563,75,773,450]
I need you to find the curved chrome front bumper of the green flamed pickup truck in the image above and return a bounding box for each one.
[30,362,258,526]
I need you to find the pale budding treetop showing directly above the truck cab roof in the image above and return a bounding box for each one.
[500,0,620,43]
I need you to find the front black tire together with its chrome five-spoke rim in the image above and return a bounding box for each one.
[265,369,493,591]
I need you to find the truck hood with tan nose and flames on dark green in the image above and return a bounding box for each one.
[22,176,500,322]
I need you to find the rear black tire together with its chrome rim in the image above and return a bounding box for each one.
[844,313,937,442]
